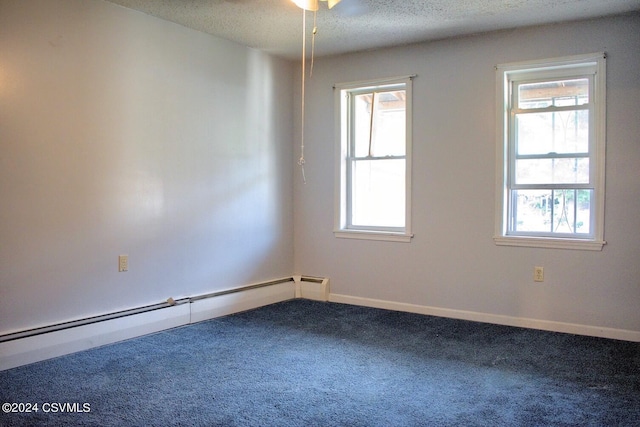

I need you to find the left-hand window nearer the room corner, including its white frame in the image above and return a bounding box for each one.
[335,77,412,242]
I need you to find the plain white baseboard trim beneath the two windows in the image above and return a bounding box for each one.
[329,294,640,342]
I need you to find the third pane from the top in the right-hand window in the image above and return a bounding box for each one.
[516,157,589,184]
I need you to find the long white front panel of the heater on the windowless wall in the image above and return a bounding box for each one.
[0,277,295,371]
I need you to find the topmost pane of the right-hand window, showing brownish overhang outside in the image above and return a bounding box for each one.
[518,79,589,109]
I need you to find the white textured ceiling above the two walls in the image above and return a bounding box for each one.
[108,0,640,59]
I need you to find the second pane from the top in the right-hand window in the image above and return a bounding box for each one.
[516,110,589,154]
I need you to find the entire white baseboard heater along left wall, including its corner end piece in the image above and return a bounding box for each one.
[0,276,329,370]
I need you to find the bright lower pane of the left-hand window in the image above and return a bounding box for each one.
[351,159,405,227]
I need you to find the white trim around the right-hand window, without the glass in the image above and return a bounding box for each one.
[493,52,606,251]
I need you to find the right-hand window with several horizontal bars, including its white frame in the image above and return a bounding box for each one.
[495,53,605,250]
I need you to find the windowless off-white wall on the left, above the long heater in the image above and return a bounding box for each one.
[0,0,293,334]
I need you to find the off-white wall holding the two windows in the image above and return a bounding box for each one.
[294,14,640,336]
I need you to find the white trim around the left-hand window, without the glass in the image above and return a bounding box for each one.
[333,75,415,242]
